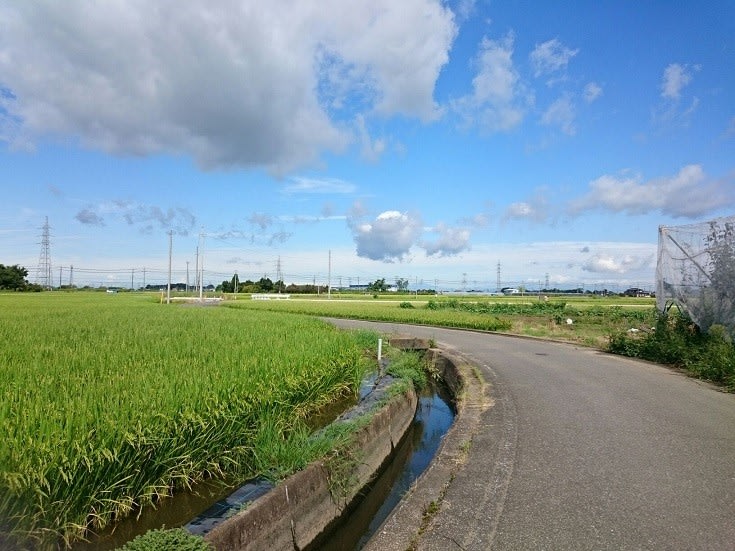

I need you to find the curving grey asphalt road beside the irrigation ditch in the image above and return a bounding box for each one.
[335,321,735,550]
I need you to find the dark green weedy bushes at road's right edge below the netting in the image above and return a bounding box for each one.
[609,313,735,392]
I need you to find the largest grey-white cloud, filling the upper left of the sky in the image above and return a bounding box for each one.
[0,0,457,172]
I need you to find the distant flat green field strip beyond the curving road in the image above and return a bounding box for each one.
[225,293,656,349]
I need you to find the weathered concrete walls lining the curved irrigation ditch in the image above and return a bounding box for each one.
[205,339,462,551]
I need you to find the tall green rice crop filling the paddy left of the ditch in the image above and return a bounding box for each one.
[0,293,372,544]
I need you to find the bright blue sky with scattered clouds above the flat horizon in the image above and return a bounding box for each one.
[0,0,735,290]
